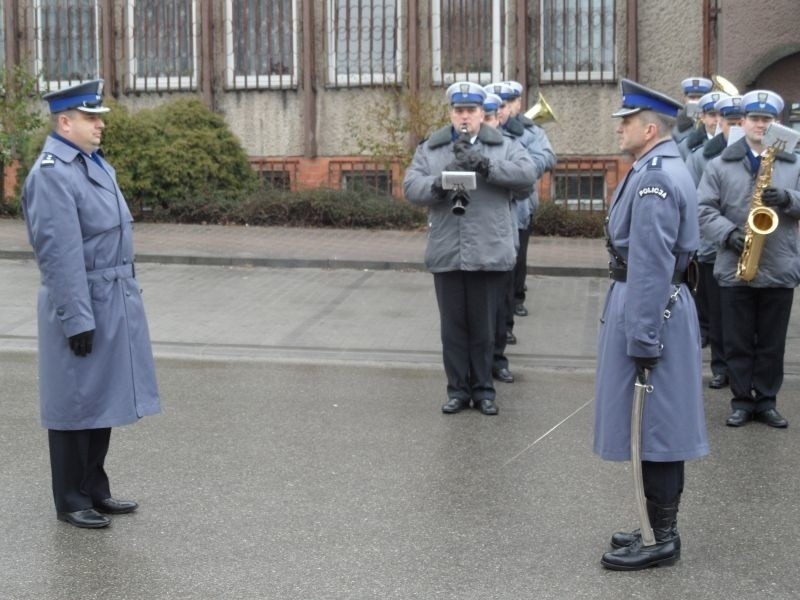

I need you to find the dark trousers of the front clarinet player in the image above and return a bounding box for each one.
[433,271,507,401]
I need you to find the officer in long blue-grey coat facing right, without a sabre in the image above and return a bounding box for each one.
[22,80,160,528]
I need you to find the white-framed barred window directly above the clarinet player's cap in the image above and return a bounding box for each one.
[431,0,508,84]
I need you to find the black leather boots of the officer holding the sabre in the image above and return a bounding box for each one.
[600,500,681,571]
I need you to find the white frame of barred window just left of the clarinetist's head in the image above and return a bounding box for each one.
[324,0,404,88]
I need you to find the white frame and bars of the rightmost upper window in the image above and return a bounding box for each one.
[538,0,617,83]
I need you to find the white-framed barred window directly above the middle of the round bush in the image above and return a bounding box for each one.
[127,0,197,90]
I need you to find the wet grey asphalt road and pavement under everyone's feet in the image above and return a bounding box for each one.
[0,220,800,600]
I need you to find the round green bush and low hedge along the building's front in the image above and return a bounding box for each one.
[0,99,602,237]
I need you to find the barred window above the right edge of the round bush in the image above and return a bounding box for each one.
[225,0,298,88]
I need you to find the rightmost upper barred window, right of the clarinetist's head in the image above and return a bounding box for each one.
[540,0,616,81]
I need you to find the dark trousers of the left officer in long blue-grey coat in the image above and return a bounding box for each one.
[47,427,111,512]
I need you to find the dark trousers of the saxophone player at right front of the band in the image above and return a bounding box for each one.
[720,286,794,412]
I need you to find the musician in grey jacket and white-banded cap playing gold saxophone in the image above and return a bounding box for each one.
[697,90,800,428]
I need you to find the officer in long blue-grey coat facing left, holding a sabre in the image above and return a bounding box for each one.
[594,79,708,570]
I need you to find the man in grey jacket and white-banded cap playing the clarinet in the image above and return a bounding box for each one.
[403,82,534,415]
